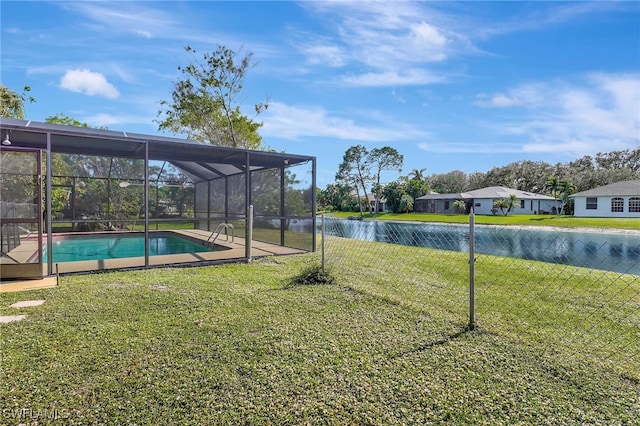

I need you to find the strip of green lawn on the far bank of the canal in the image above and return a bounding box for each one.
[329,212,640,230]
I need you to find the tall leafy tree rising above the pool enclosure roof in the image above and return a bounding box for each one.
[158,46,268,149]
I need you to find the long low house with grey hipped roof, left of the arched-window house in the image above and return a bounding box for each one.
[413,186,560,214]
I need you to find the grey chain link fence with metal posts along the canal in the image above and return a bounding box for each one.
[319,215,640,370]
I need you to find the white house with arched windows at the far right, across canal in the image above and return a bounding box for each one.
[572,180,640,218]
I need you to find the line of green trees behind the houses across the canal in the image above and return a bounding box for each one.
[318,145,640,214]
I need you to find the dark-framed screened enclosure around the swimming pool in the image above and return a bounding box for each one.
[0,118,316,280]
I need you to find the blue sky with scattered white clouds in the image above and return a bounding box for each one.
[0,1,640,187]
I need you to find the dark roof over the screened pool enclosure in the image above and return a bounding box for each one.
[0,117,314,182]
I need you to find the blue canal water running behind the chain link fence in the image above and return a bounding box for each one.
[325,218,640,275]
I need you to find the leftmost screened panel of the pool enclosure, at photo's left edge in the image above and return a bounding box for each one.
[0,147,43,279]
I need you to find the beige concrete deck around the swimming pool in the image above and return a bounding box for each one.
[0,229,306,284]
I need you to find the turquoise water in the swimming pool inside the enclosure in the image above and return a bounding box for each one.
[43,234,210,263]
